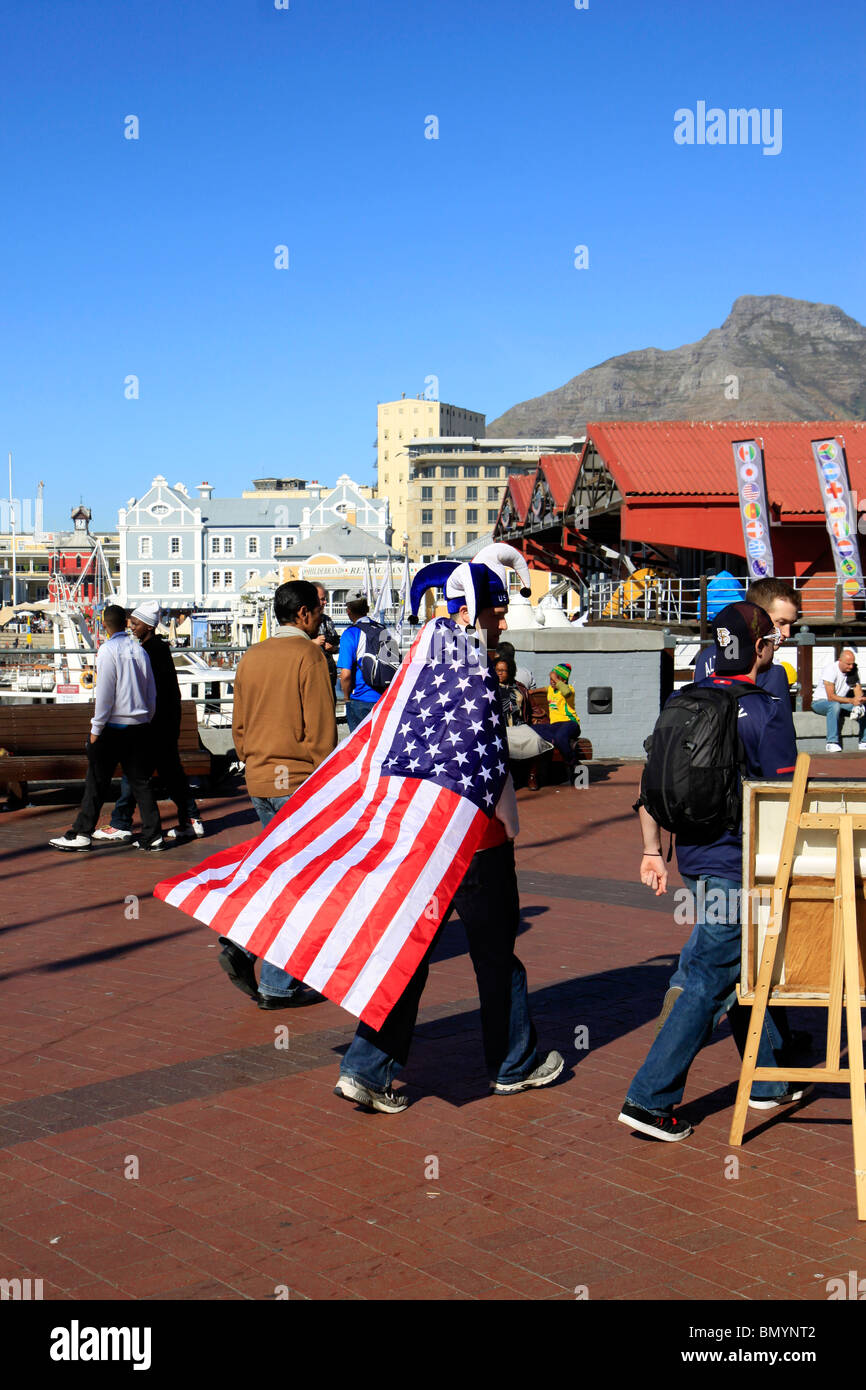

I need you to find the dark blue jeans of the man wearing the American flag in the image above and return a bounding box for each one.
[339,842,539,1091]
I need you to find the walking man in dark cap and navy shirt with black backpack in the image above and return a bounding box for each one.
[619,602,805,1143]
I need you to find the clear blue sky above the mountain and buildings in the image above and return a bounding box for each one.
[0,0,866,528]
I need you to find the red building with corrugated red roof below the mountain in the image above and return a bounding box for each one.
[495,420,866,616]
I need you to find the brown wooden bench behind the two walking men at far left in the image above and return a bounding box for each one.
[0,701,211,801]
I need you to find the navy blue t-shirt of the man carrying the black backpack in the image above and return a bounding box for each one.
[670,671,796,880]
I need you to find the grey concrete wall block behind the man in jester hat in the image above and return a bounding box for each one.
[505,627,673,758]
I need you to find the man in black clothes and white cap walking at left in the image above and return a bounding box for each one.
[93,600,204,844]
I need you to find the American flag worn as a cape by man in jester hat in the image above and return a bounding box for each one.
[154,619,507,1027]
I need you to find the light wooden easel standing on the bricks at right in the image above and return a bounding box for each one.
[730,753,866,1220]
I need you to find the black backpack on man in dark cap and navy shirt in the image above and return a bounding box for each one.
[635,685,762,842]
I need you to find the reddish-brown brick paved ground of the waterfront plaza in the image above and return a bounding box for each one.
[0,758,866,1300]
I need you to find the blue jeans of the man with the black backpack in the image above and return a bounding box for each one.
[627,874,788,1115]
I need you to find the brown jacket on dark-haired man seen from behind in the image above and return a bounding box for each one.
[232,624,336,796]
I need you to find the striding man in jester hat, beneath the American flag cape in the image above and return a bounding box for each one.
[335,546,564,1115]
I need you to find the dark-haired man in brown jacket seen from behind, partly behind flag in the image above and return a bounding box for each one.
[220,580,336,1009]
